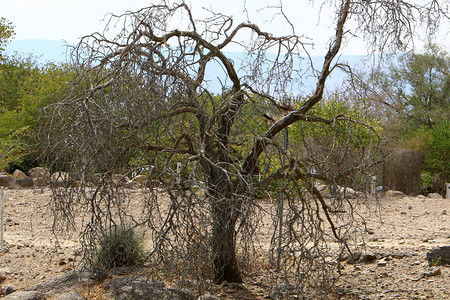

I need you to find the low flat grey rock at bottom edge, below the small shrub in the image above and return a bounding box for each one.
[104,277,194,300]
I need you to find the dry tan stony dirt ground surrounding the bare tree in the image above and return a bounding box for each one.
[0,188,450,299]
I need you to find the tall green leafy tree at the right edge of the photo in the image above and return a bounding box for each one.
[350,44,450,194]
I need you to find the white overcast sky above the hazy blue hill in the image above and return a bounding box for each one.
[0,0,445,55]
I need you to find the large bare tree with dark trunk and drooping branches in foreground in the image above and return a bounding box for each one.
[42,0,446,293]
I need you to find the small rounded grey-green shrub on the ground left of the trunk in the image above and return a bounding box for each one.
[94,225,145,269]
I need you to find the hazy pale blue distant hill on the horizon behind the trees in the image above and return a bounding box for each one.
[6,40,364,94]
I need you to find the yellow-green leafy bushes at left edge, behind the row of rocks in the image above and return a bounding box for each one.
[0,56,72,171]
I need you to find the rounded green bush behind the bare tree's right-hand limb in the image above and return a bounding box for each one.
[258,97,382,192]
